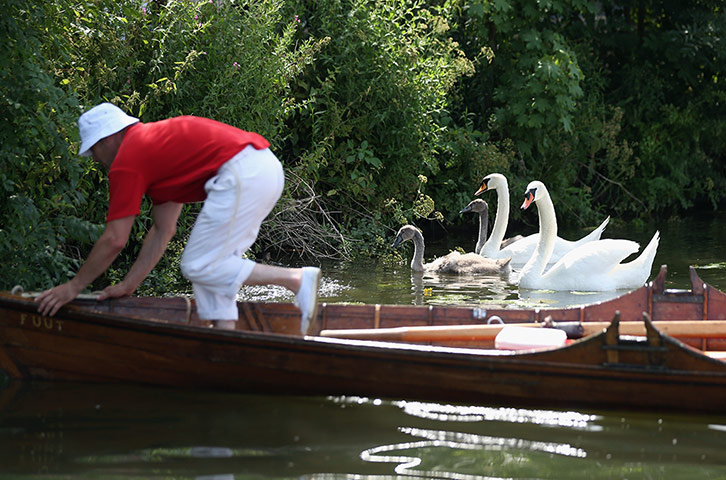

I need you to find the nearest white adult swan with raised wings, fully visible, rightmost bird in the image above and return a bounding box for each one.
[519,181,660,292]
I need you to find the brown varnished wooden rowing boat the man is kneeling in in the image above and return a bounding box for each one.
[0,267,726,412]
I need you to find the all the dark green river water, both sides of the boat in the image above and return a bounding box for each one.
[0,215,726,480]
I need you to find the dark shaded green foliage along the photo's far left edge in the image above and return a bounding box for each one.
[0,1,98,288]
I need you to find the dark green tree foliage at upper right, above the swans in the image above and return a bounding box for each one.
[457,0,726,223]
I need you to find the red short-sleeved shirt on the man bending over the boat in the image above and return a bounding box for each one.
[106,116,270,221]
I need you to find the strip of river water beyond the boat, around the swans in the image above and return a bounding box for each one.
[241,209,726,307]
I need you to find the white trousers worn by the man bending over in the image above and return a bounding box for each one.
[181,146,285,320]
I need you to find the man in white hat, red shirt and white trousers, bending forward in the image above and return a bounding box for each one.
[36,103,320,334]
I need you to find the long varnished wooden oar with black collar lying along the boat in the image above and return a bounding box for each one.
[320,320,726,342]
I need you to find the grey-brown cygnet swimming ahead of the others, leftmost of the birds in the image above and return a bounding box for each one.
[393,225,511,275]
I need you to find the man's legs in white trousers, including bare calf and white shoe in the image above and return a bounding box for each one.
[182,150,320,334]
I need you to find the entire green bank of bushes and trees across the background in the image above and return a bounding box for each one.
[0,0,726,293]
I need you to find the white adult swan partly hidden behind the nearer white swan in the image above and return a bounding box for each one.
[474,173,610,266]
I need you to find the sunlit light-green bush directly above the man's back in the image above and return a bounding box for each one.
[57,0,319,142]
